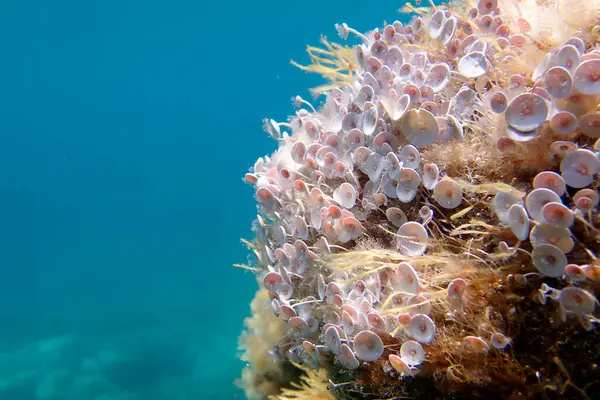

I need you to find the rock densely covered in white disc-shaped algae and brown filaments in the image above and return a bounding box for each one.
[238,0,600,399]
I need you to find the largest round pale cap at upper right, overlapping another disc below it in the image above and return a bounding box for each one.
[504,93,548,132]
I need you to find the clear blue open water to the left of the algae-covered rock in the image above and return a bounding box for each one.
[0,0,401,400]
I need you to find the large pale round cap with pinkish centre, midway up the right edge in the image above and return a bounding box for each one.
[560,149,600,189]
